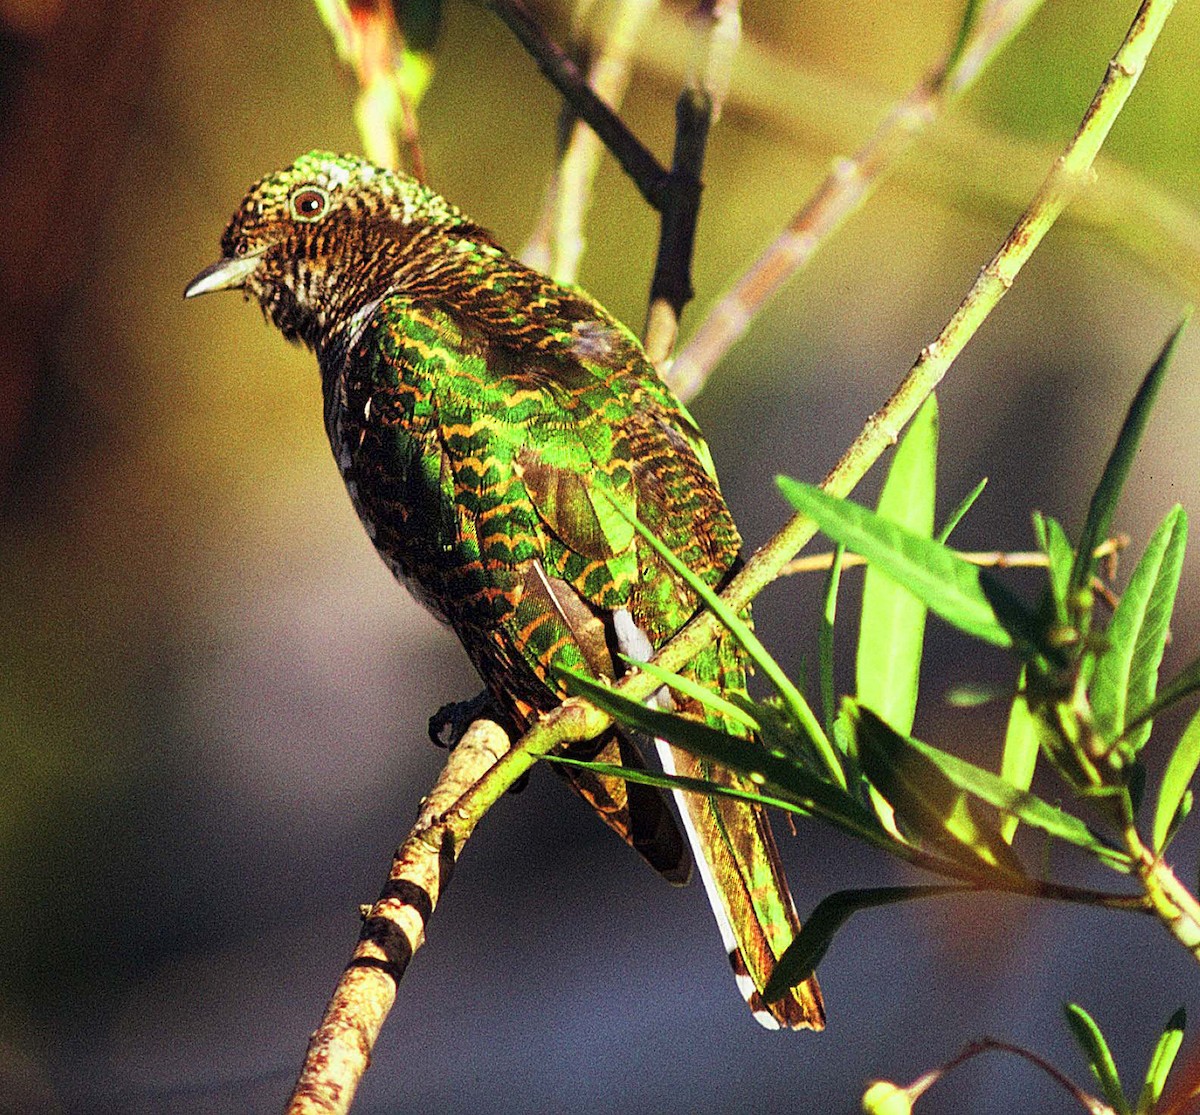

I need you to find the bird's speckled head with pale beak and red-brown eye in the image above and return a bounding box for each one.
[184,151,468,347]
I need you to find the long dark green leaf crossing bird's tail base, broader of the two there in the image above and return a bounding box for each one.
[558,670,881,844]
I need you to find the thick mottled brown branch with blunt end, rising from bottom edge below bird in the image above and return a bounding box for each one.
[287,720,509,1115]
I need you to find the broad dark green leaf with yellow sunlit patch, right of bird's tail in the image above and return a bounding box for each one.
[846,701,1025,877]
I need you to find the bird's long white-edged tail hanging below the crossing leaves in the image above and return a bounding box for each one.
[656,739,824,1030]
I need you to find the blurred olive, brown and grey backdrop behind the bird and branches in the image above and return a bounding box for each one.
[0,0,1200,1115]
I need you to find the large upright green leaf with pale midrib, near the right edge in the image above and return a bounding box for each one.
[1090,504,1188,750]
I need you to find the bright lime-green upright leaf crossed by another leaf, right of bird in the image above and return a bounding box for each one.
[856,395,937,732]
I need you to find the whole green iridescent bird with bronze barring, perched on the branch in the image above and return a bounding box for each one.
[186,151,824,1029]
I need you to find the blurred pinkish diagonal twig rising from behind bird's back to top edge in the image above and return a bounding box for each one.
[666,0,1042,402]
